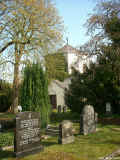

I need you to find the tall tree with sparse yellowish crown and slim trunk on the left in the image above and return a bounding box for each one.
[0,0,62,112]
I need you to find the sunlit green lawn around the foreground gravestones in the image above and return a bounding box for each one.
[0,123,120,160]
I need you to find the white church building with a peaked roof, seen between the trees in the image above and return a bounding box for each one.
[48,44,90,108]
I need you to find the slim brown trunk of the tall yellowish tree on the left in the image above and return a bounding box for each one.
[12,44,20,113]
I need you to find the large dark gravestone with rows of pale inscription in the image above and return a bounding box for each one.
[14,112,43,157]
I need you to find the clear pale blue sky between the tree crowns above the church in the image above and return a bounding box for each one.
[55,0,96,47]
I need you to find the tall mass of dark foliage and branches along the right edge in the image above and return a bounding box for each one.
[77,0,120,114]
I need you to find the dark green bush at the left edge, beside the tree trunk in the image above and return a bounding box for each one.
[0,80,13,112]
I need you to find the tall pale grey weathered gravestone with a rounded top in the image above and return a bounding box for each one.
[80,105,98,135]
